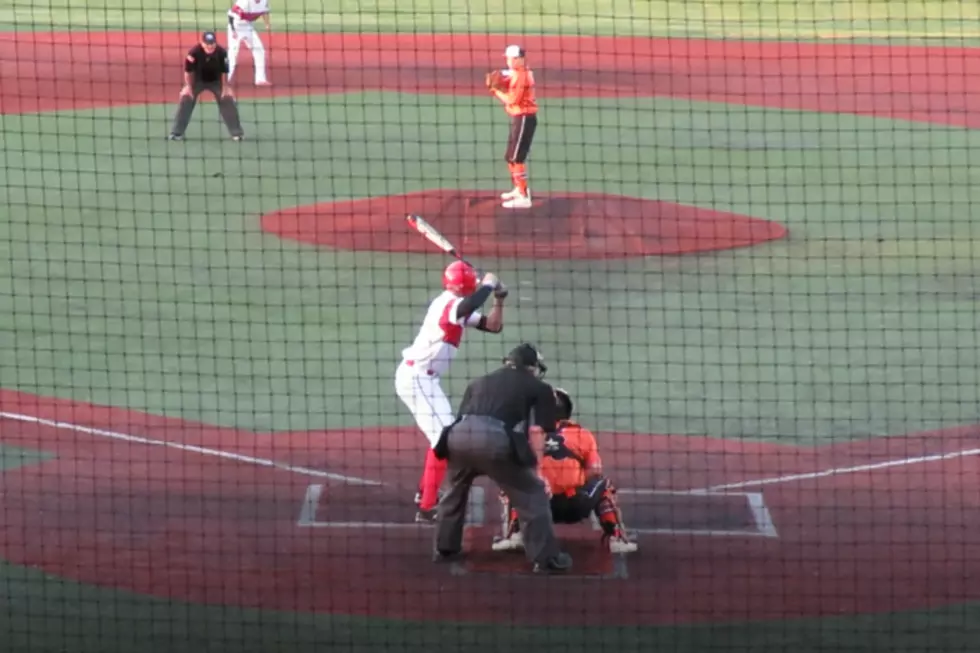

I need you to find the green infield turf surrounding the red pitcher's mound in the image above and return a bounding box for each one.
[0,93,980,444]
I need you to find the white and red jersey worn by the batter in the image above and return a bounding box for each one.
[402,290,482,375]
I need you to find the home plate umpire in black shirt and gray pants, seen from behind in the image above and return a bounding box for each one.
[434,343,572,572]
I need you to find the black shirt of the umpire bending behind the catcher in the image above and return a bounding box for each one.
[459,366,557,436]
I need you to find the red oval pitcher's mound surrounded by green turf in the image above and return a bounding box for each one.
[262,190,786,259]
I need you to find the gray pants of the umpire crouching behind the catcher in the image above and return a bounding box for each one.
[435,416,561,563]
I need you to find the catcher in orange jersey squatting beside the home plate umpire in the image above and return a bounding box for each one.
[493,388,639,553]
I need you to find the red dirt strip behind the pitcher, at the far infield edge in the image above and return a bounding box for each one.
[0,32,980,127]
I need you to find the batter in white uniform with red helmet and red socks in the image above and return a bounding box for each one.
[395,261,507,522]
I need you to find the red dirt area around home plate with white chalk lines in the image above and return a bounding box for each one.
[0,391,980,625]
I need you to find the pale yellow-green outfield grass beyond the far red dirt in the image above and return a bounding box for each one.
[0,0,980,41]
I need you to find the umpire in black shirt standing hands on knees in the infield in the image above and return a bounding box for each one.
[170,32,245,141]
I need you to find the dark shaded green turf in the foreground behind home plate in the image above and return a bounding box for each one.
[0,562,980,653]
